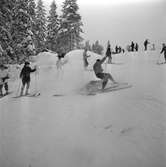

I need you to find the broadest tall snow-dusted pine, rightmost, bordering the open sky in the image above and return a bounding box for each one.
[58,0,83,52]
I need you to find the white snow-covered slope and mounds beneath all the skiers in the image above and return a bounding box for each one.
[0,50,166,167]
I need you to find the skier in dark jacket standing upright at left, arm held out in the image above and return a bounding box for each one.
[20,61,36,96]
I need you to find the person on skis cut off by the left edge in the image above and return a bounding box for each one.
[0,64,9,97]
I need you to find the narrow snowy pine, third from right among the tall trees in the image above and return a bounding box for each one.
[36,0,47,52]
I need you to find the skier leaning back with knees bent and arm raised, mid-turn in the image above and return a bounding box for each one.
[93,56,117,89]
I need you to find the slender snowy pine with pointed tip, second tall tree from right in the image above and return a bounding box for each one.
[46,0,59,51]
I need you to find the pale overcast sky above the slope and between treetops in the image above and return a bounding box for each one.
[39,0,166,47]
